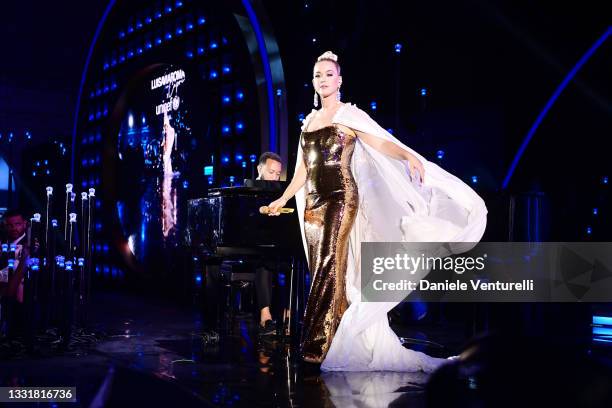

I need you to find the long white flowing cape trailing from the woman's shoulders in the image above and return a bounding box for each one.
[295,103,487,372]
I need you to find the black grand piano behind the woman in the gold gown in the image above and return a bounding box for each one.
[187,182,306,338]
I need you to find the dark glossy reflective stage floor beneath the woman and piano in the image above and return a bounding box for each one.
[0,293,612,407]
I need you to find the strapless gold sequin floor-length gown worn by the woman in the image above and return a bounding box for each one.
[300,125,359,363]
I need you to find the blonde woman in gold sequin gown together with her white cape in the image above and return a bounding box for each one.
[269,51,487,372]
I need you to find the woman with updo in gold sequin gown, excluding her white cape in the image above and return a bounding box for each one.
[269,52,423,363]
